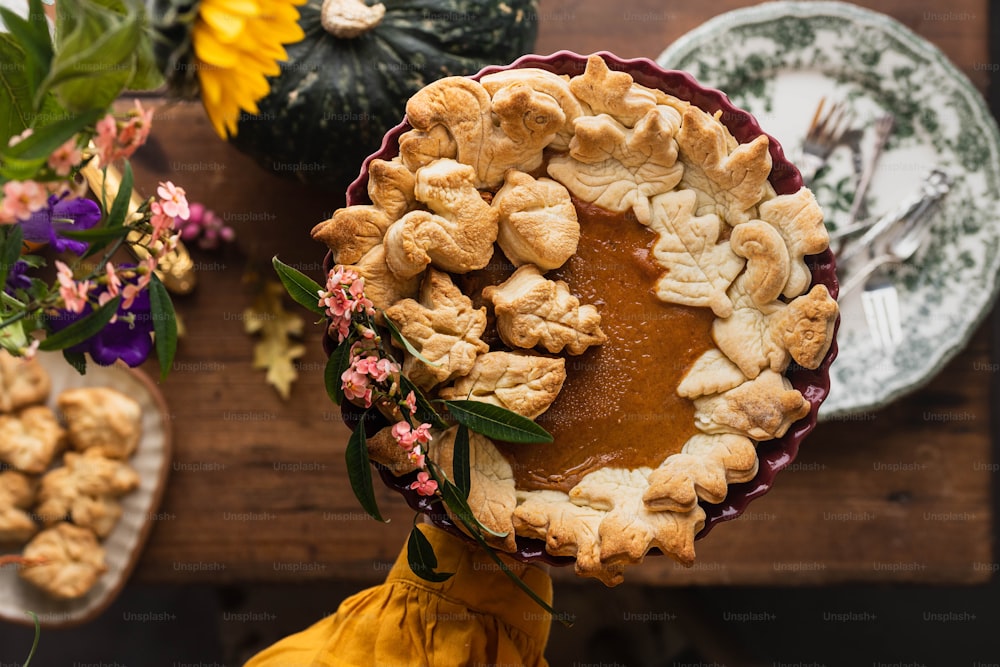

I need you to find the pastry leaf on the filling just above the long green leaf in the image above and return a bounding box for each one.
[438,352,566,419]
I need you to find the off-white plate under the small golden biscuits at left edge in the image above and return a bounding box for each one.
[0,354,172,627]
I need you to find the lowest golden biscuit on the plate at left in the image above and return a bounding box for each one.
[20,523,107,600]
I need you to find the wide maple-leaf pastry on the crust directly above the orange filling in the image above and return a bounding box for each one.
[548,106,684,225]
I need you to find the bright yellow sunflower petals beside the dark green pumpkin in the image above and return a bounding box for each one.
[191,0,305,139]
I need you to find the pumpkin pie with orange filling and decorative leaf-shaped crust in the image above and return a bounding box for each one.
[313,56,838,585]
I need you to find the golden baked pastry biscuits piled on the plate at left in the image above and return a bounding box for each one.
[0,350,142,599]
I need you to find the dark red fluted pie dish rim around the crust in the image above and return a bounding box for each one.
[324,51,839,565]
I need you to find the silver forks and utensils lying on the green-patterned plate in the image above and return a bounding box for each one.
[799,98,951,351]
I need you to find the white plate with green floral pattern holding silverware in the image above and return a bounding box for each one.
[657,2,1000,419]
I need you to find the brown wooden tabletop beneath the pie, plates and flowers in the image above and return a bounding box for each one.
[136,0,998,585]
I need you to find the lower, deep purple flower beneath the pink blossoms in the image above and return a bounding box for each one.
[49,280,153,367]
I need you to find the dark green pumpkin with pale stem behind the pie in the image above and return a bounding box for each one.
[231,0,538,185]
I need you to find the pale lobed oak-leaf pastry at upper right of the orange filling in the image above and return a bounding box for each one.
[650,190,744,317]
